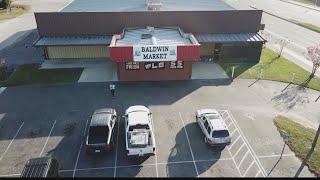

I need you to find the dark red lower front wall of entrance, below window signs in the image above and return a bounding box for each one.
[117,61,192,81]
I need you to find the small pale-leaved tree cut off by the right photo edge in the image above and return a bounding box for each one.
[302,44,320,86]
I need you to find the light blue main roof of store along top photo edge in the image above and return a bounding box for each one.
[61,0,234,12]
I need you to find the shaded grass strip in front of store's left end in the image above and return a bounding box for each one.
[0,64,82,86]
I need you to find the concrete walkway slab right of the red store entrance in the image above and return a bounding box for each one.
[191,62,229,79]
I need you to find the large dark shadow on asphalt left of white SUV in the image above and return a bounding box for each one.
[166,122,225,177]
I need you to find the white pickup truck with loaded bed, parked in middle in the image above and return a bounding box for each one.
[124,106,156,156]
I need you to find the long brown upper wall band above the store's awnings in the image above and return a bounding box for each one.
[35,10,262,36]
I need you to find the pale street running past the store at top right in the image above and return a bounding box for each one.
[225,0,320,76]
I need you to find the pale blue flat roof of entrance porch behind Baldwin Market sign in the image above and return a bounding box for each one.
[115,28,192,46]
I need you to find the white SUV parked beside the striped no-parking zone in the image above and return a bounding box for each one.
[196,109,231,145]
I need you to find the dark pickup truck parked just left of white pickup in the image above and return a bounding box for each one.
[86,108,117,154]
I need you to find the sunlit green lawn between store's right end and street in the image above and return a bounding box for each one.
[221,48,320,91]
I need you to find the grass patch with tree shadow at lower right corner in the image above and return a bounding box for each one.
[274,116,320,176]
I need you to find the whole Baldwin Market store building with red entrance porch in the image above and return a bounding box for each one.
[35,0,265,81]
